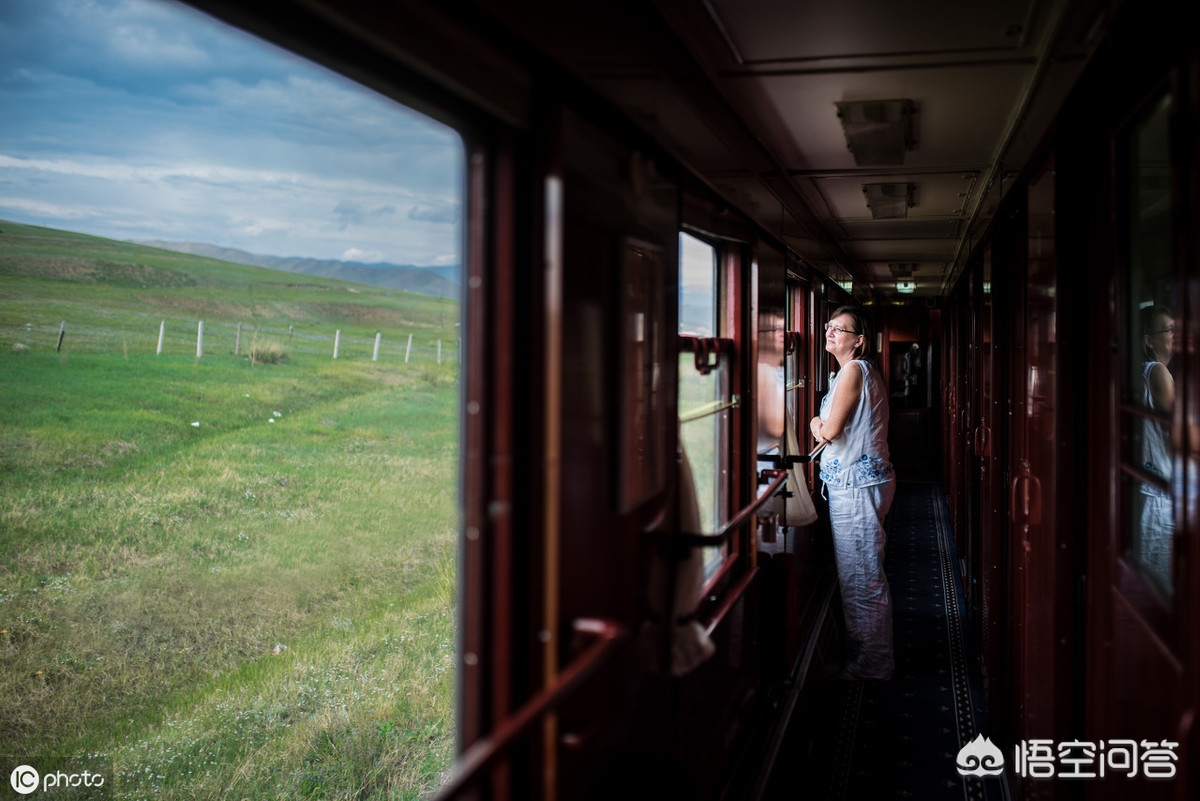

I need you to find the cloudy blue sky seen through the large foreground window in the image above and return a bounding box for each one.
[0,0,462,266]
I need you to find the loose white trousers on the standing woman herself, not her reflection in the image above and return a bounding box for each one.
[826,481,895,679]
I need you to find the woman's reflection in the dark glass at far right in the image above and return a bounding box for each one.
[1134,306,1175,589]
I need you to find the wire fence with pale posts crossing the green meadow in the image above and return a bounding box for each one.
[0,318,462,365]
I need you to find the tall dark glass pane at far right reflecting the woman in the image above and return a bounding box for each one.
[1124,90,1183,596]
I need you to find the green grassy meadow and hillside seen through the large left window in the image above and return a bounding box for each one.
[0,221,458,799]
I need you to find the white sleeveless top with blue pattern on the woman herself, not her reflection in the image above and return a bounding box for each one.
[821,360,895,487]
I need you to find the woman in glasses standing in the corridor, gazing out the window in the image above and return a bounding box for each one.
[809,306,895,679]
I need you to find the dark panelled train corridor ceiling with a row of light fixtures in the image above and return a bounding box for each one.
[481,0,1111,302]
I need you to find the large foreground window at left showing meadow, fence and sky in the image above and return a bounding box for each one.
[0,0,466,799]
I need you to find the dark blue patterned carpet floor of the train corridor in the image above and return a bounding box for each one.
[762,481,1009,801]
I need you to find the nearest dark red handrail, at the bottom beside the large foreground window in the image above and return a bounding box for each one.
[434,618,624,801]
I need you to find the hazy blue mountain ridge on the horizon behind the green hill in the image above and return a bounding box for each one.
[137,240,458,299]
